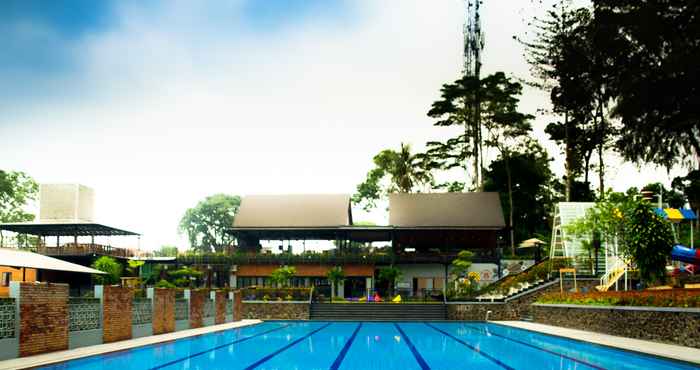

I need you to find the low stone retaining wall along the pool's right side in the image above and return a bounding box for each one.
[532,303,700,348]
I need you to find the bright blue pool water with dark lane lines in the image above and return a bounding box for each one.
[41,321,700,370]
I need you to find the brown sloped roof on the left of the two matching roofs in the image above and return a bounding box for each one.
[233,194,352,229]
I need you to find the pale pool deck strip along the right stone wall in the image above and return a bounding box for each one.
[492,321,700,364]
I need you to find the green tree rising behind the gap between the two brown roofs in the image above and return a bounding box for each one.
[352,143,432,210]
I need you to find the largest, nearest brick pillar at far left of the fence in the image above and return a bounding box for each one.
[10,281,68,357]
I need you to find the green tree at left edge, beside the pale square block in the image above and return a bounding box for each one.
[0,170,39,222]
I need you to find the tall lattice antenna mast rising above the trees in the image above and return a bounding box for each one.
[464,0,484,191]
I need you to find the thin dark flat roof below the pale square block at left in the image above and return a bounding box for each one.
[0,222,139,236]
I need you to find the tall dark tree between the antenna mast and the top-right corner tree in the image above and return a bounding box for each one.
[520,0,614,201]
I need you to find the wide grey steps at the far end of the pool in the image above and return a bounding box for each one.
[311,303,447,321]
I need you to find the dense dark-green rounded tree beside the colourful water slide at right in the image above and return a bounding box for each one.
[627,203,673,284]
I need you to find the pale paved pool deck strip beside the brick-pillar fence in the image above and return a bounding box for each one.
[0,320,262,370]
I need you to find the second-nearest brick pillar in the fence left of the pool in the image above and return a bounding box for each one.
[95,285,134,343]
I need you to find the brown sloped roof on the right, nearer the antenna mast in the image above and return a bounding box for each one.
[389,193,505,230]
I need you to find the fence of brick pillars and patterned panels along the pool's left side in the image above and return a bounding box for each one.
[0,282,242,360]
